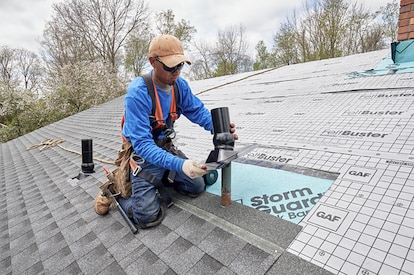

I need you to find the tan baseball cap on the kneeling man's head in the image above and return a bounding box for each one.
[149,34,191,68]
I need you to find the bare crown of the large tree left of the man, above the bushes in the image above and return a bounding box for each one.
[42,0,148,72]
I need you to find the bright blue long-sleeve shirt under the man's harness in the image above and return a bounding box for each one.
[122,72,213,171]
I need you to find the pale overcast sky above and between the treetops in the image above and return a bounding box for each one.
[0,0,392,56]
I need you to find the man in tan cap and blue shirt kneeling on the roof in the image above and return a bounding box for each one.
[118,35,238,227]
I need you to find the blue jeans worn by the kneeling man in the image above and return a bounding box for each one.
[118,162,205,224]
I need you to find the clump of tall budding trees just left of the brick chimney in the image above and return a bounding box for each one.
[273,0,398,64]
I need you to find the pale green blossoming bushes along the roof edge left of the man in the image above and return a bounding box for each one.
[0,60,125,142]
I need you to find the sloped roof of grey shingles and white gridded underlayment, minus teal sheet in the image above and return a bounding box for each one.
[0,48,414,274]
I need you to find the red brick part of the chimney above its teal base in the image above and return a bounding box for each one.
[397,0,414,41]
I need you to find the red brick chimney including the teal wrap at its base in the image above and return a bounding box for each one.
[391,0,414,64]
